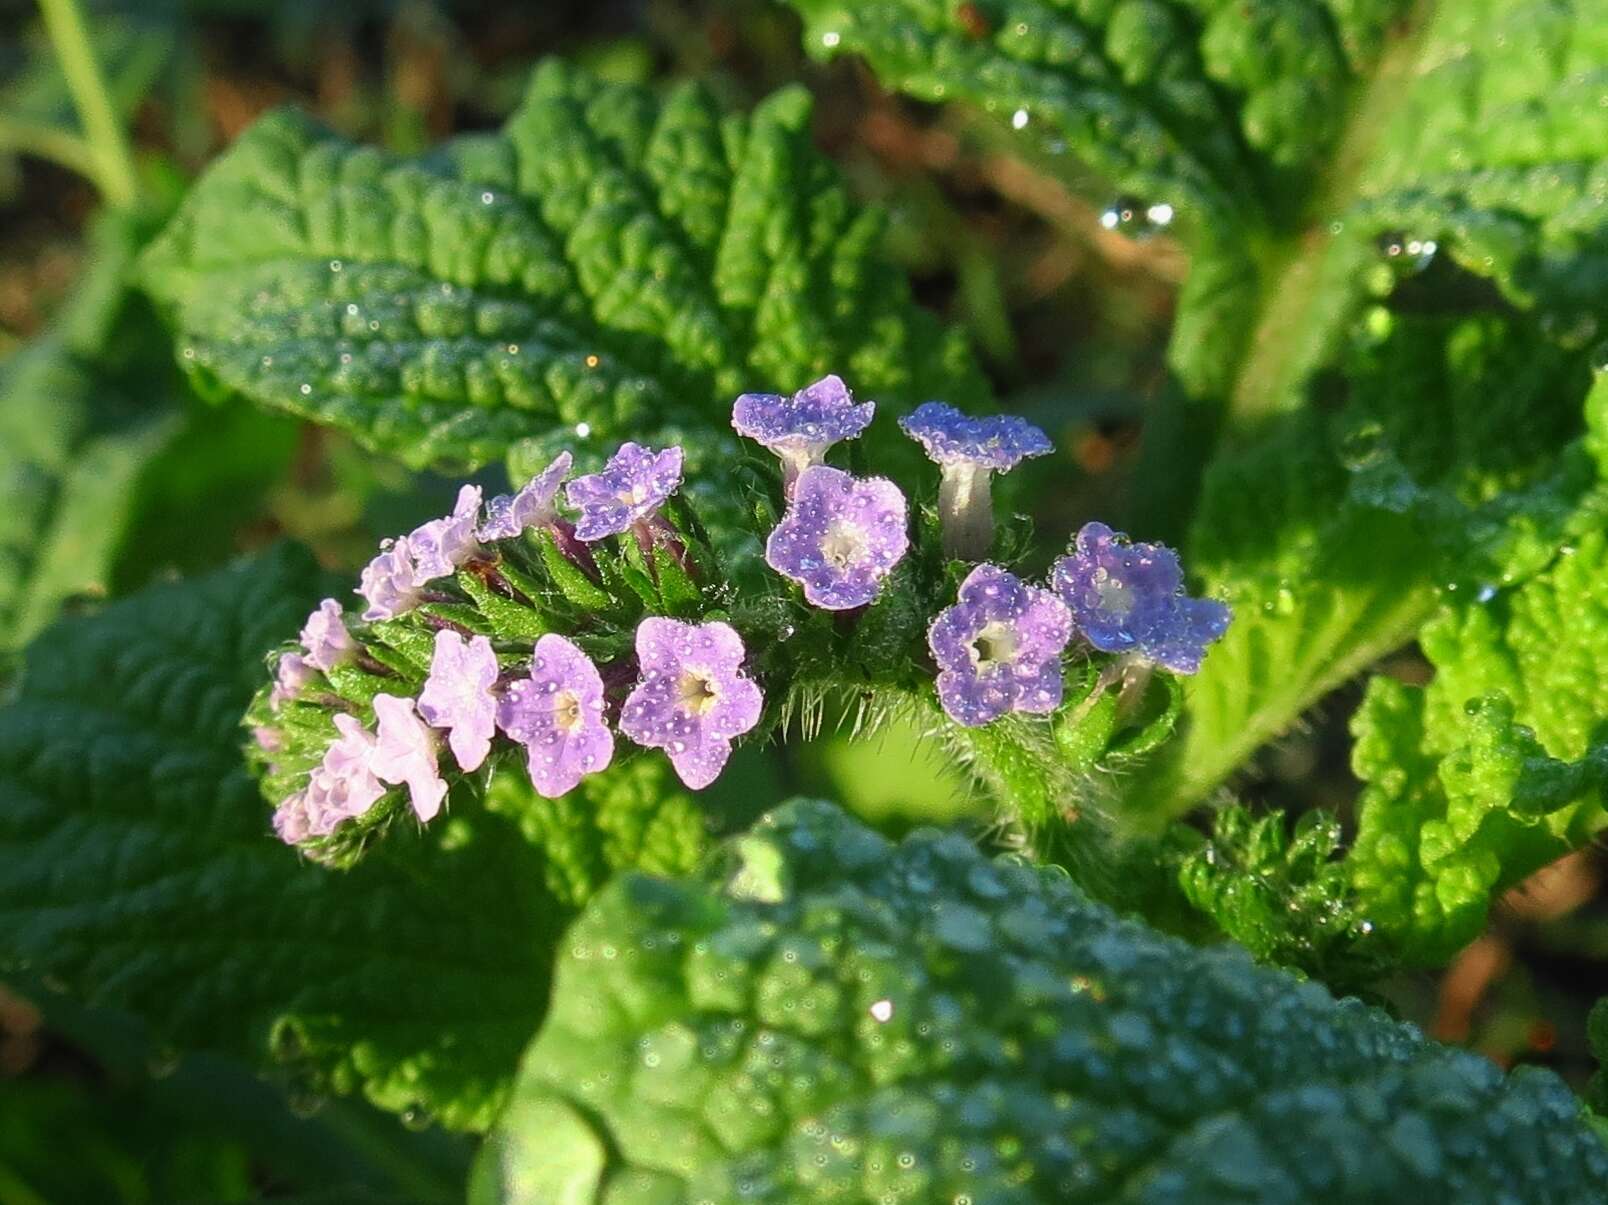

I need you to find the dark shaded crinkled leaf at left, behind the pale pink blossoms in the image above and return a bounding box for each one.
[0,547,703,1128]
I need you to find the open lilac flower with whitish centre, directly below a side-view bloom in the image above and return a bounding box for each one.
[765,465,910,611]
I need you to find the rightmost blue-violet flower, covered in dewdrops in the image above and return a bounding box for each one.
[1050,523,1233,674]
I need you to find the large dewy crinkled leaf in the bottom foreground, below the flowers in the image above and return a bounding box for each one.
[473,803,1608,1205]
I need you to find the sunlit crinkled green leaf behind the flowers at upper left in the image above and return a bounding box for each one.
[145,61,984,467]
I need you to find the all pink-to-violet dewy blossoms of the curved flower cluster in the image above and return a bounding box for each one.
[270,376,1230,843]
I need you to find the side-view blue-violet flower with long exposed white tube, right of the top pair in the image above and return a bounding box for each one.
[899,402,1055,560]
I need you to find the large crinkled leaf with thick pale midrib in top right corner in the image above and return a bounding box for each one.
[790,0,1608,418]
